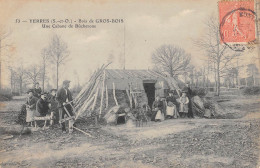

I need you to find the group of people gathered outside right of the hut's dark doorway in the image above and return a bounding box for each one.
[151,84,193,121]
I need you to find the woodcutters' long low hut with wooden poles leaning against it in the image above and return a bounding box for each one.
[75,66,184,118]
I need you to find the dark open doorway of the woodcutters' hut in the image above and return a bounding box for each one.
[143,80,156,108]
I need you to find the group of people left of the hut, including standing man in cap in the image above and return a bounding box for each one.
[18,80,74,133]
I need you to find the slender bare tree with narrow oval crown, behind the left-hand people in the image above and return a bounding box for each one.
[48,35,69,89]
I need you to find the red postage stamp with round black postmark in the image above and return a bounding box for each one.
[219,1,256,51]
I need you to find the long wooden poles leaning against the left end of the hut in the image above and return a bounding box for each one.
[74,64,109,119]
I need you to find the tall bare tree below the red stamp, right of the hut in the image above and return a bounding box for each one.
[194,16,239,96]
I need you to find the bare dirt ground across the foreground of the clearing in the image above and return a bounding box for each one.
[0,96,260,168]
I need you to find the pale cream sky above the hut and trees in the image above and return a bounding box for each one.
[0,0,254,86]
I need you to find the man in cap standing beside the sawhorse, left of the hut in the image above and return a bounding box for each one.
[57,80,73,133]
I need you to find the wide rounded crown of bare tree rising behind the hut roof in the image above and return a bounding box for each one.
[152,45,190,77]
